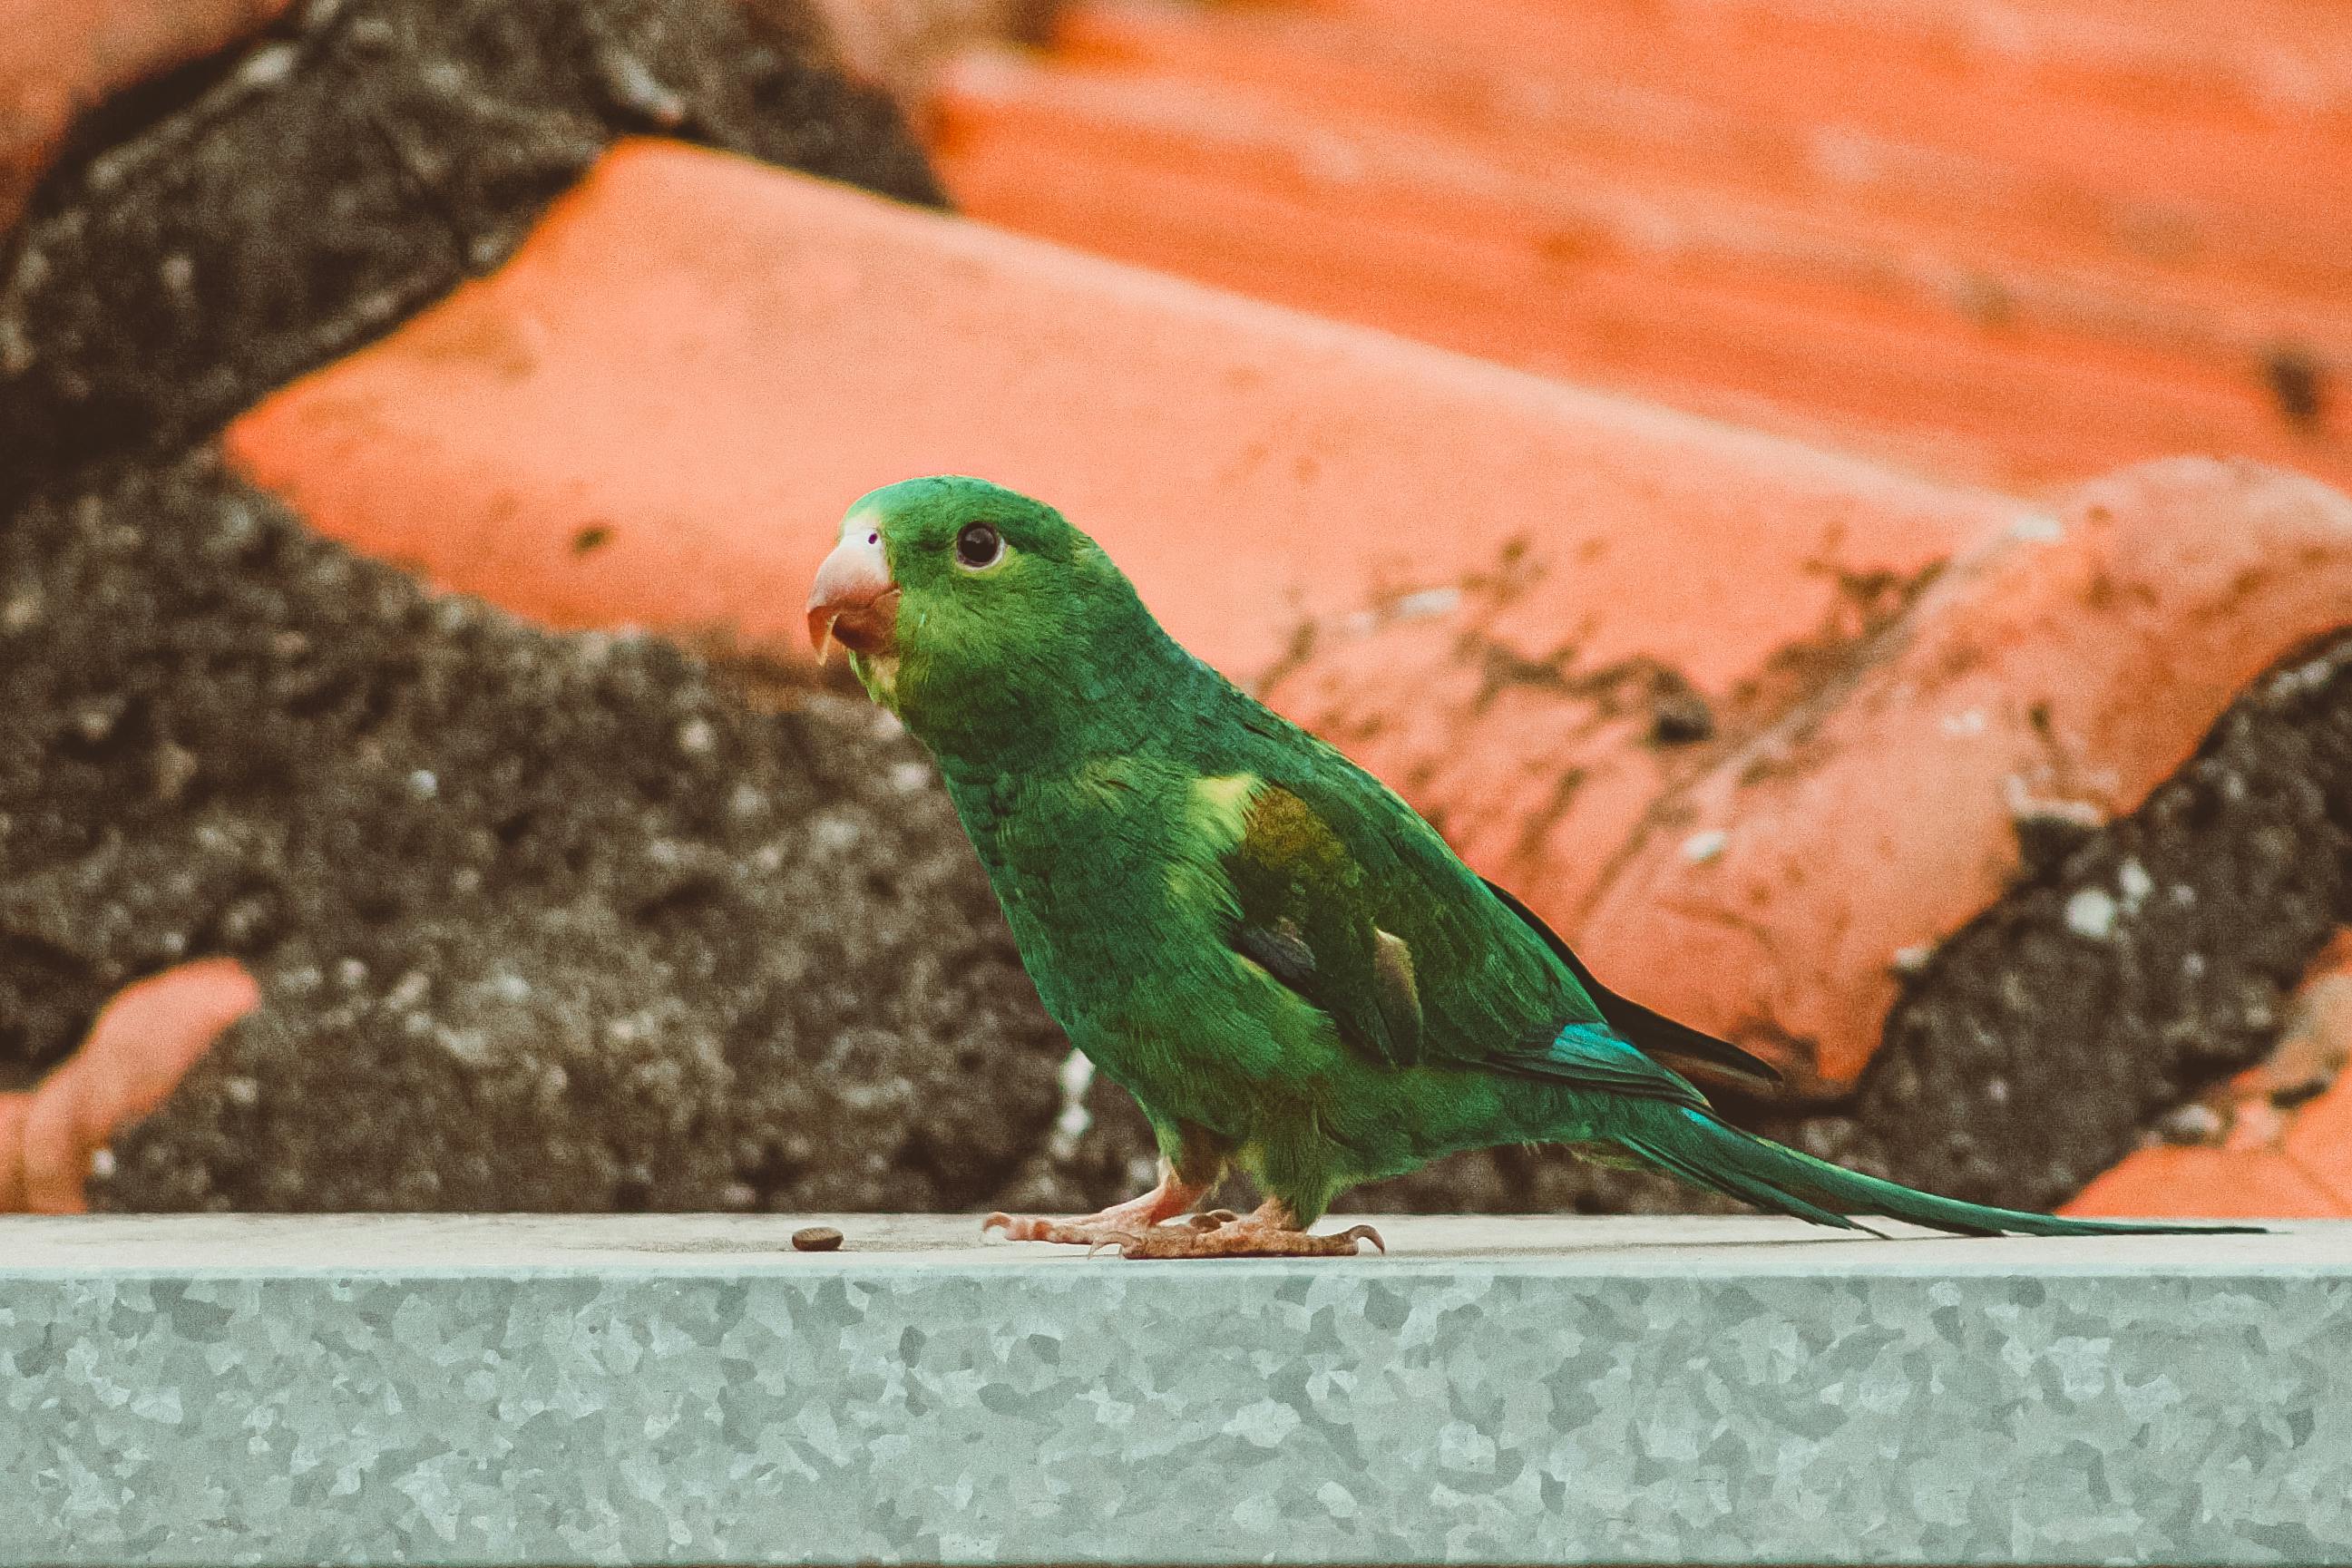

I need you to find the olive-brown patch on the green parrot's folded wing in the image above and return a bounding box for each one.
[1223,781,1420,1067]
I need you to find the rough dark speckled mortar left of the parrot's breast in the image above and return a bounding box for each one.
[0,458,1066,1208]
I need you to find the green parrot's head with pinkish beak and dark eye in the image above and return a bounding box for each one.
[809,475,1171,762]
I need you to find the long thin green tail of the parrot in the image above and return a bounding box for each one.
[1614,1100,2262,1236]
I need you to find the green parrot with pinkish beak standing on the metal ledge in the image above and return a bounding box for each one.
[809,475,2258,1258]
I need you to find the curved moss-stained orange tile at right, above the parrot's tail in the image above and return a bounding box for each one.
[1540,458,2352,1086]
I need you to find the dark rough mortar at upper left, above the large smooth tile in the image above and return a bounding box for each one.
[0,0,939,501]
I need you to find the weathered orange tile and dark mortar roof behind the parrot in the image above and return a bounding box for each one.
[0,0,2352,1215]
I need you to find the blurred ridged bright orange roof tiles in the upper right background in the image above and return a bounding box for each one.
[933,5,2352,484]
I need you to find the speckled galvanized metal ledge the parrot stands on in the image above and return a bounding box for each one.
[0,1215,2352,1565]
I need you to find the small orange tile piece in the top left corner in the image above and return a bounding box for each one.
[0,0,287,233]
